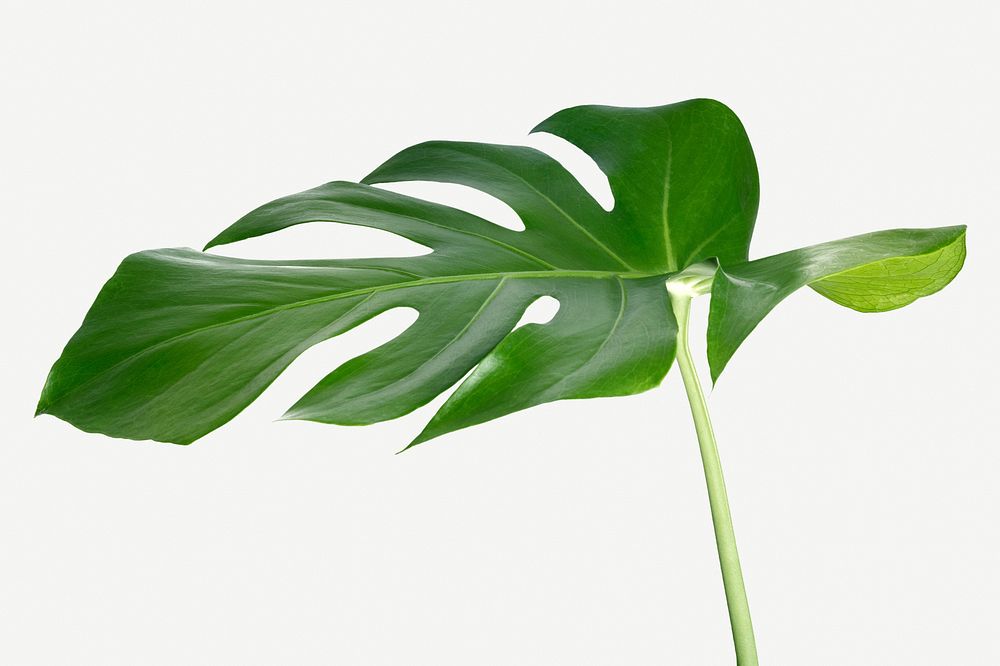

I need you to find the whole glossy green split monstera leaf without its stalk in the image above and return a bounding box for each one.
[38,100,965,444]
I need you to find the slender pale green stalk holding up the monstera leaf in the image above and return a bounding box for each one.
[669,291,757,666]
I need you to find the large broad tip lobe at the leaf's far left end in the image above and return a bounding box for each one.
[38,249,413,444]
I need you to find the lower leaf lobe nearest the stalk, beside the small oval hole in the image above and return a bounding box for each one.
[410,277,677,446]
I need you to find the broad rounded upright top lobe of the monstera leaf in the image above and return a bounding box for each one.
[533,99,760,272]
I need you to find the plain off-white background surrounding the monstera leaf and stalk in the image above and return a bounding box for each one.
[0,0,1000,666]
